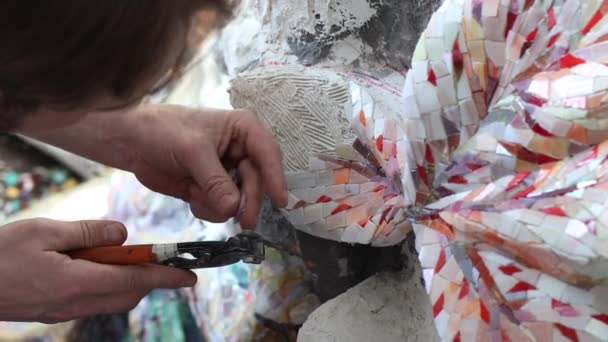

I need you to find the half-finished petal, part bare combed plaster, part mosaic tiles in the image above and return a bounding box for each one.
[230,65,414,246]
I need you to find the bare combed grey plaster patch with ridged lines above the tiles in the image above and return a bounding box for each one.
[230,66,354,172]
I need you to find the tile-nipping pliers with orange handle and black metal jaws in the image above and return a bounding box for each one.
[67,232,265,269]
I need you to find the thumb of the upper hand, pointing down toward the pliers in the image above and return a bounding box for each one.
[188,146,240,220]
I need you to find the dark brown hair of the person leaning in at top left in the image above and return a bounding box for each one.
[0,0,231,130]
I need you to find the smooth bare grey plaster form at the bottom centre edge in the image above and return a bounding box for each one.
[298,267,439,342]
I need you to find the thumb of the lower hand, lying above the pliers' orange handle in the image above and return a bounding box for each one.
[43,220,127,252]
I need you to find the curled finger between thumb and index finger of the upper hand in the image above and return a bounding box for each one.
[237,159,262,229]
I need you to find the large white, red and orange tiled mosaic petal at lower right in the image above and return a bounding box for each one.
[414,143,608,341]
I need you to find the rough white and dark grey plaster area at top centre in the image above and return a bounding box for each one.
[217,0,441,75]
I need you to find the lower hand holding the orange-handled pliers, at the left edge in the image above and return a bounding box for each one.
[0,219,196,323]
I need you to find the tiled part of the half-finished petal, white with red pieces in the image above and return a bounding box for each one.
[286,82,414,246]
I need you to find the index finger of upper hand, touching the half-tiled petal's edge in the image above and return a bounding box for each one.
[237,116,287,207]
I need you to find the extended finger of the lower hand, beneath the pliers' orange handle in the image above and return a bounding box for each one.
[65,260,197,296]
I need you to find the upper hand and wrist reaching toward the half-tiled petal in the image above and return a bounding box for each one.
[18,105,287,228]
